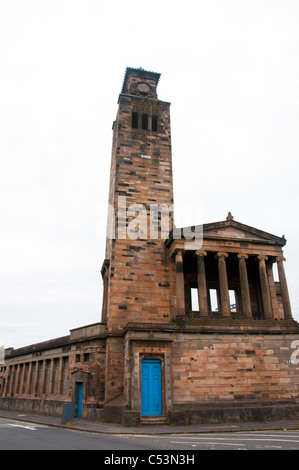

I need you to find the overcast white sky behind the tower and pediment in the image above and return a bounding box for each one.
[0,0,299,347]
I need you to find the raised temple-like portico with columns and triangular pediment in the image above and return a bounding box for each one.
[166,214,292,320]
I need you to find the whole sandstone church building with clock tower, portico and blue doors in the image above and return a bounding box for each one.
[0,68,299,425]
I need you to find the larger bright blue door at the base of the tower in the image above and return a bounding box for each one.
[141,359,162,416]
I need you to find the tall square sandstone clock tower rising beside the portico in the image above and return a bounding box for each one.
[102,68,173,399]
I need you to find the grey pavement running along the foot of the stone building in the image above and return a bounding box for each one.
[0,410,299,435]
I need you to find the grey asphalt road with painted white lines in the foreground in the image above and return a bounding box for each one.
[0,418,299,452]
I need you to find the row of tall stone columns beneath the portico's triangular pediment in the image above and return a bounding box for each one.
[175,249,292,319]
